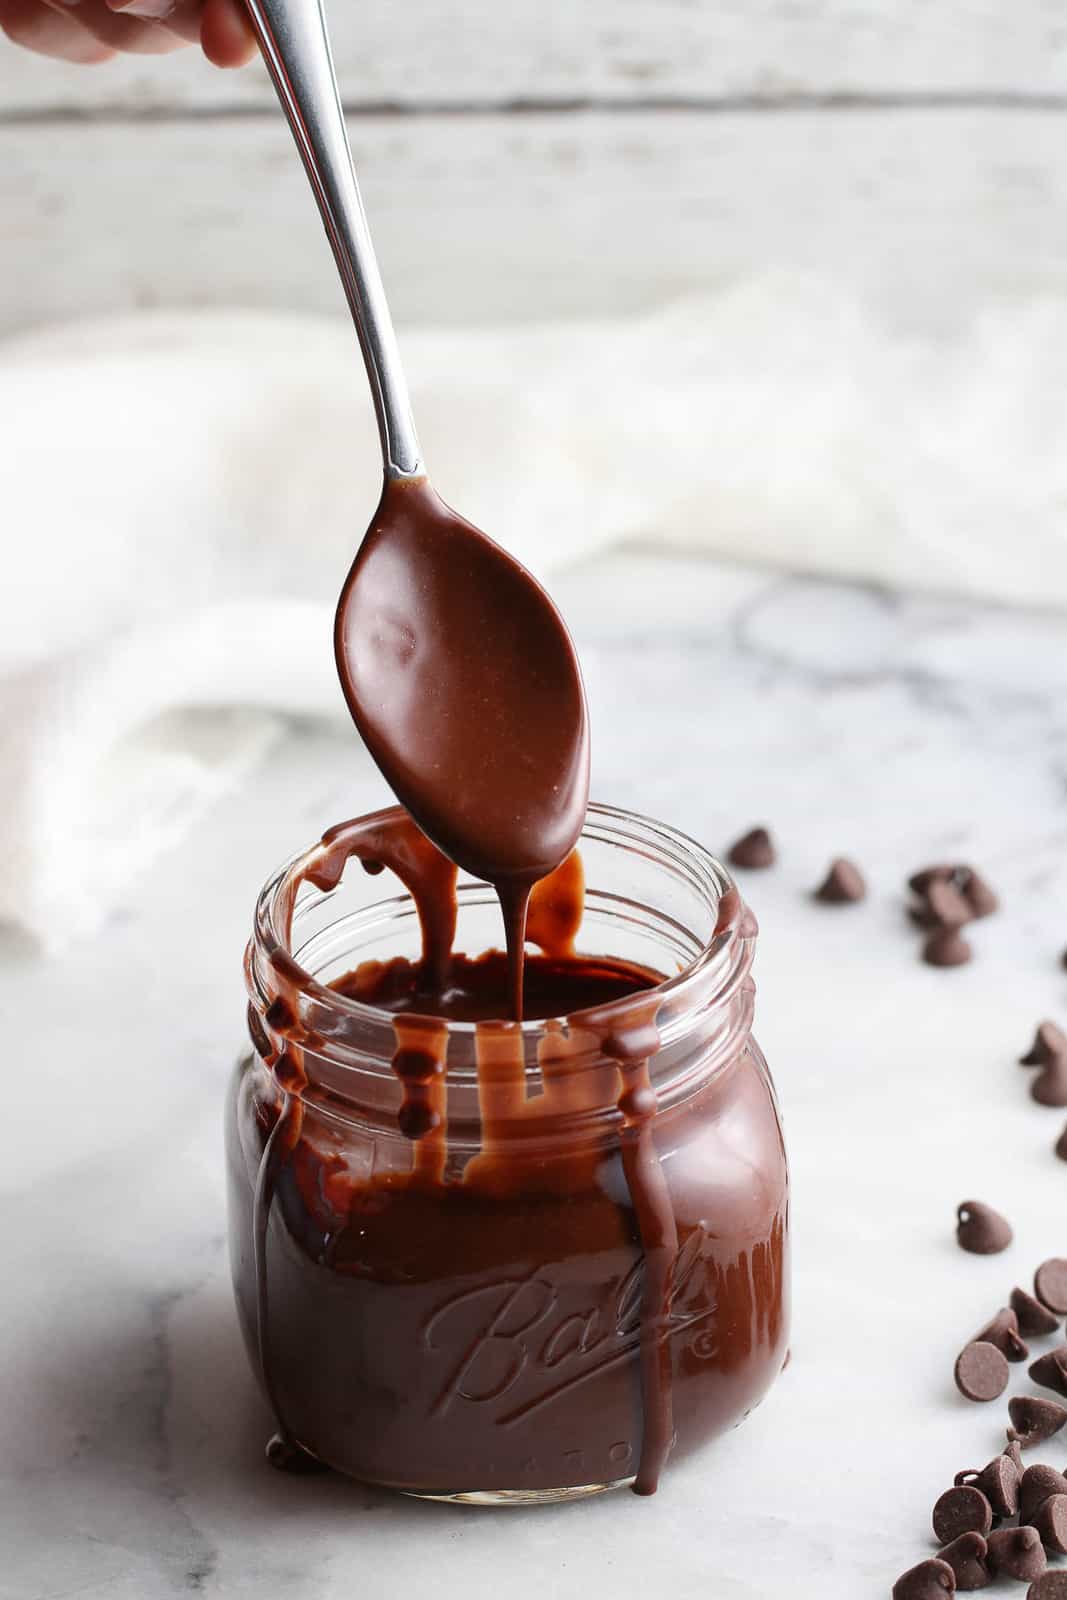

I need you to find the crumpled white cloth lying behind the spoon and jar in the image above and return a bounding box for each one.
[0,274,1067,946]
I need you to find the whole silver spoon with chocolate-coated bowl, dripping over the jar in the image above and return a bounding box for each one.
[248,0,589,1014]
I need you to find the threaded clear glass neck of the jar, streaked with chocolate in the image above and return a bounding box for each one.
[245,806,757,1142]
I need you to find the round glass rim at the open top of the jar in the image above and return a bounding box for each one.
[246,802,758,1038]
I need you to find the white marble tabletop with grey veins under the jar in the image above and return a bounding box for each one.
[0,555,1067,1600]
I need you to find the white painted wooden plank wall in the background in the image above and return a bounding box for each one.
[0,0,1067,328]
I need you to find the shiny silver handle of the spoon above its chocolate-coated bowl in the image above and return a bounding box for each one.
[246,0,424,478]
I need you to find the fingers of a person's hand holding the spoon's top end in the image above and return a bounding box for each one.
[0,0,256,67]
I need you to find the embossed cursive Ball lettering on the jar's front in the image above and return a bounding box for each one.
[422,1224,717,1427]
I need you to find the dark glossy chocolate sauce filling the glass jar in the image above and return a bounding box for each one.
[229,813,785,1493]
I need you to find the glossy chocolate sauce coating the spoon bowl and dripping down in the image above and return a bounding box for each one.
[334,478,589,1019]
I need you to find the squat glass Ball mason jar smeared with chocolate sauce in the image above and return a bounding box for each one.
[226,806,789,1502]
